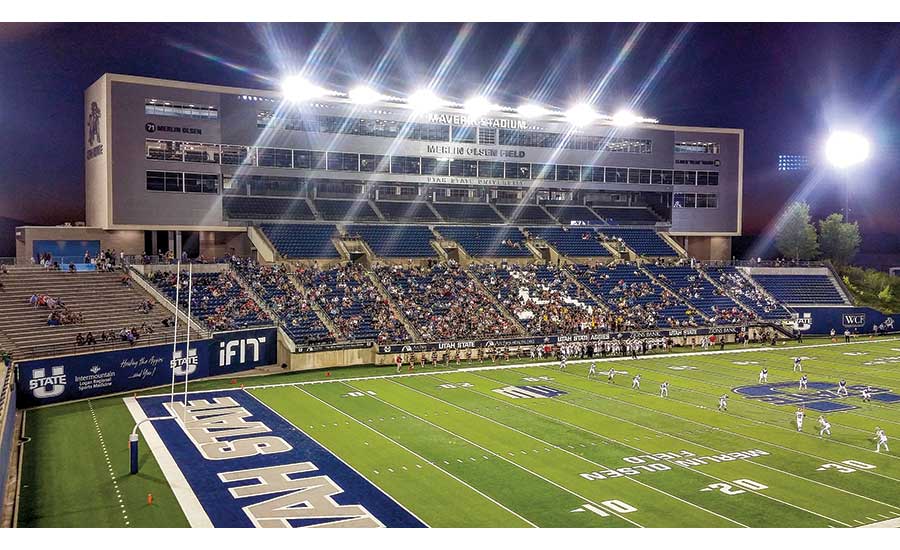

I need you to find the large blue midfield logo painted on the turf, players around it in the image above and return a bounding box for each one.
[732,382,900,412]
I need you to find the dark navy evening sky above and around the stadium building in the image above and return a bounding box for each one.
[0,23,900,240]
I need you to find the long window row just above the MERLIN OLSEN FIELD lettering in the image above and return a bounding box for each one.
[256,111,653,154]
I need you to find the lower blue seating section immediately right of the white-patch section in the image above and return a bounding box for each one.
[570,264,704,330]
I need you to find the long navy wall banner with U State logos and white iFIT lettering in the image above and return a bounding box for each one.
[16,328,277,408]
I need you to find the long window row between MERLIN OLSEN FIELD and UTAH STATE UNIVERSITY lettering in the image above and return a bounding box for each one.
[146,139,719,185]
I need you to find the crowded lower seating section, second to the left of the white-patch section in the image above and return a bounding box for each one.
[297,264,410,344]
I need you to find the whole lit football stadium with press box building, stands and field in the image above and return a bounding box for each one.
[0,19,900,528]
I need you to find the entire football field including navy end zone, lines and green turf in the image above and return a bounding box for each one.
[19,340,900,527]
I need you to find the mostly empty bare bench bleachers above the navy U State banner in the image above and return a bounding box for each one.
[0,267,174,359]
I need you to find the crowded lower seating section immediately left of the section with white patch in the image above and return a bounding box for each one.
[376,261,519,342]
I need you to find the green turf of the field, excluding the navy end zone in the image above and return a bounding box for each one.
[12,340,900,527]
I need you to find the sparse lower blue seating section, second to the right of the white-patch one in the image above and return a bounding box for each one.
[644,265,752,325]
